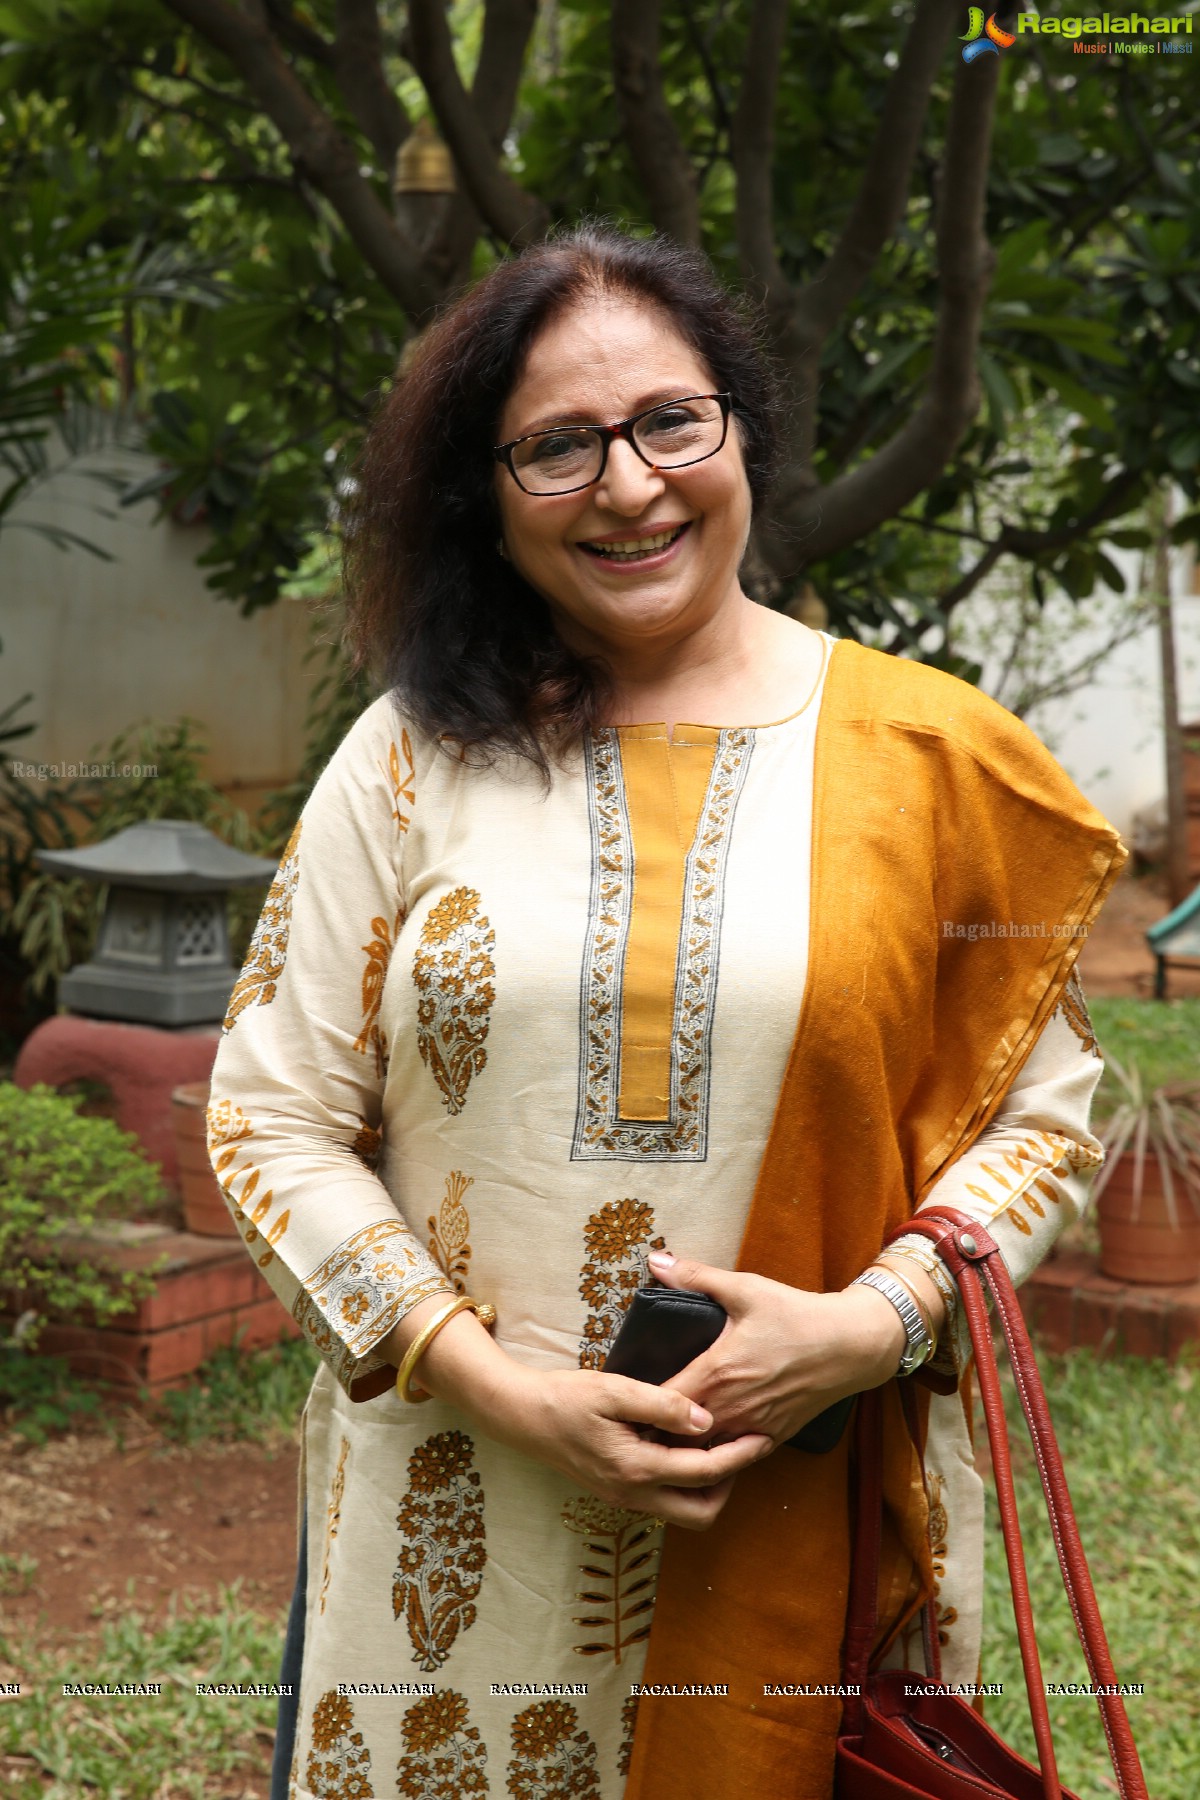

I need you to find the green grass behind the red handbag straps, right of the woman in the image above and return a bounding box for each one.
[982,1350,1200,1800]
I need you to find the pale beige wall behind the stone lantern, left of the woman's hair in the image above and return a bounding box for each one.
[0,454,318,787]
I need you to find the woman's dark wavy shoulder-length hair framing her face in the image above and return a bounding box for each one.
[345,225,777,774]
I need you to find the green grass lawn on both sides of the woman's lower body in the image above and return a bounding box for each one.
[0,1352,1200,1800]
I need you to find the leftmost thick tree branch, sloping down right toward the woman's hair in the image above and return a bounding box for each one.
[162,0,439,317]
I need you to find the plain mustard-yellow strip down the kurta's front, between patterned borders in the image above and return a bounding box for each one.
[617,725,720,1120]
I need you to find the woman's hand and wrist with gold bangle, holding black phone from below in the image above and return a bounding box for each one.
[387,1303,772,1532]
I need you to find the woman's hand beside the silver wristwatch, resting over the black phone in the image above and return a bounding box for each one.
[649,1251,905,1444]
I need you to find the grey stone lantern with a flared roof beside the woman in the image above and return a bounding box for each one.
[34,819,275,1026]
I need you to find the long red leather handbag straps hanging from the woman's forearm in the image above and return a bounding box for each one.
[895,1206,1150,1800]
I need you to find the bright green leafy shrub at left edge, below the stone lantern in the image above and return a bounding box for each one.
[0,1082,164,1346]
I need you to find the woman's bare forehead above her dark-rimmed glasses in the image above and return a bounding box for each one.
[502,295,712,437]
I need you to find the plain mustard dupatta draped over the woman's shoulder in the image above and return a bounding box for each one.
[626,641,1126,1800]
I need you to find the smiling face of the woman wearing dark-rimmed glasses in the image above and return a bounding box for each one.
[497,293,759,698]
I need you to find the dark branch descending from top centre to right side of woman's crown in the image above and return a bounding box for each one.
[612,0,700,245]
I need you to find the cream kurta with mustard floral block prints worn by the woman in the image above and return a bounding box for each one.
[209,637,1099,1800]
